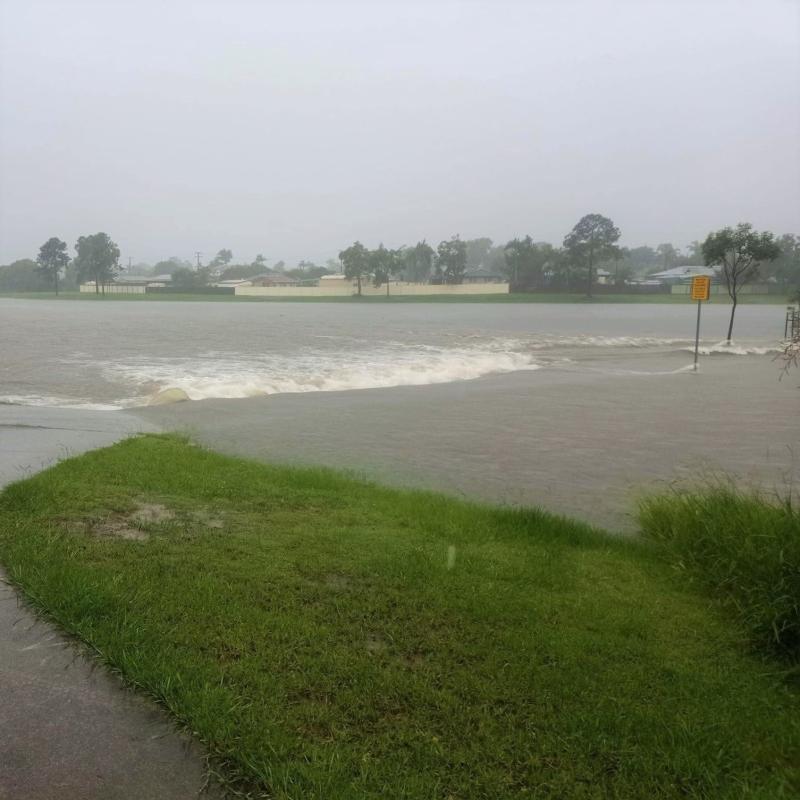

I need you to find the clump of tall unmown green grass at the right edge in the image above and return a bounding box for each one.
[639,486,800,662]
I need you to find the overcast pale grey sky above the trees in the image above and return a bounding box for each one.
[0,0,800,263]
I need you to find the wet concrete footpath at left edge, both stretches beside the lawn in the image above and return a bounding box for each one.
[0,405,222,800]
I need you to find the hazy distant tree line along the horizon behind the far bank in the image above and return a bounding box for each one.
[0,219,800,312]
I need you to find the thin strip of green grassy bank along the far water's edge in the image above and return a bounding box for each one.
[0,292,788,305]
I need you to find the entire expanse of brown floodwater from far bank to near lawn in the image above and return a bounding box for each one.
[0,299,800,530]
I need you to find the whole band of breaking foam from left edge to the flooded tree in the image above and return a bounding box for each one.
[0,331,780,410]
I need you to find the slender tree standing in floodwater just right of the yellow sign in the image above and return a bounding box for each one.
[703,222,781,342]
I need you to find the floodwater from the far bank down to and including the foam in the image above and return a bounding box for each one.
[0,299,783,409]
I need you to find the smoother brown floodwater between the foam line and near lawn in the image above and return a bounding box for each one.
[136,353,800,532]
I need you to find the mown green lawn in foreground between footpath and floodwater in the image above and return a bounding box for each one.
[0,436,800,800]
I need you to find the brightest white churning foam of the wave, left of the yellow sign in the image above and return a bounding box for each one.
[97,347,540,400]
